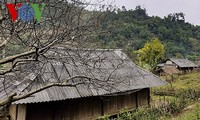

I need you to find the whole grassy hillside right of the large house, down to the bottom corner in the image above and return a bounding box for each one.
[152,72,200,120]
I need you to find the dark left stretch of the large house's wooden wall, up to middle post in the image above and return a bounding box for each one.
[27,97,101,120]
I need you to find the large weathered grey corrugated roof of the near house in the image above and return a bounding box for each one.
[0,48,166,104]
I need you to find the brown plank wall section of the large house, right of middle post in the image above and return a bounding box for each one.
[104,89,150,115]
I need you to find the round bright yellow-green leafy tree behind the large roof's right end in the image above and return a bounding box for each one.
[136,38,165,71]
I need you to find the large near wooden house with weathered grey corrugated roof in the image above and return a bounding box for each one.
[0,48,166,120]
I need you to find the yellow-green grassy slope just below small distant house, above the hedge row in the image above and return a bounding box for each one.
[152,72,200,101]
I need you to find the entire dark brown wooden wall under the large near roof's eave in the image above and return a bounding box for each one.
[9,88,149,120]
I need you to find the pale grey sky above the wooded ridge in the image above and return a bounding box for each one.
[88,0,200,25]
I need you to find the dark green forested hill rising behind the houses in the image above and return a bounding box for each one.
[98,6,200,59]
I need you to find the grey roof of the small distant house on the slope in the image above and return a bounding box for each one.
[169,58,198,68]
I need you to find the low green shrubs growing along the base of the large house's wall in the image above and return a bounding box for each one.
[99,99,187,120]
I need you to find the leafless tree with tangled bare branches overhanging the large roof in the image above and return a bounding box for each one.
[0,0,120,116]
